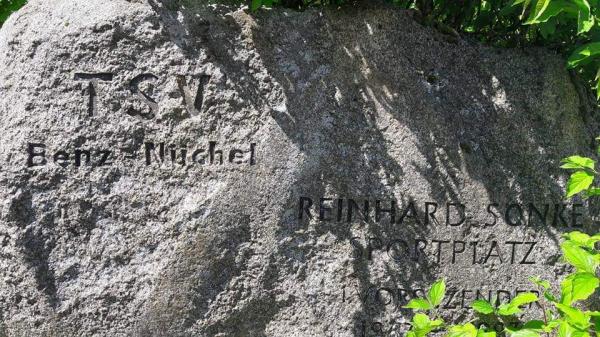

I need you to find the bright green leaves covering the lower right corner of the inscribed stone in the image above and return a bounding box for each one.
[406,230,600,337]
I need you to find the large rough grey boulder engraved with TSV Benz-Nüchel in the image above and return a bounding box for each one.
[0,0,598,337]
